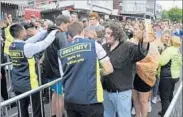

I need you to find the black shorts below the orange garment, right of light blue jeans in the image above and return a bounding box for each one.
[133,74,152,92]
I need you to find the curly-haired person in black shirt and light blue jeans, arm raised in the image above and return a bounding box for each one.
[103,22,153,117]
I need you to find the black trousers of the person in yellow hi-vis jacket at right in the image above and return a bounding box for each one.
[159,78,179,115]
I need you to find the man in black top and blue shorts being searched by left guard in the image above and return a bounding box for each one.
[43,15,70,117]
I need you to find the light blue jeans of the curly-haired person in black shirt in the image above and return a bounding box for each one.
[104,90,132,117]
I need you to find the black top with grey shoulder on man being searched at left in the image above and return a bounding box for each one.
[43,27,68,79]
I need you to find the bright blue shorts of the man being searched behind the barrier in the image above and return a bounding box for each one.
[48,79,63,95]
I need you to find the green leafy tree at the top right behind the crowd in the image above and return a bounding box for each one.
[167,7,182,21]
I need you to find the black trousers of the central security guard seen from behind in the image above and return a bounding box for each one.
[65,103,104,117]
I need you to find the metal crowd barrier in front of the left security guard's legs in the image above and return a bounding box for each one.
[0,59,67,117]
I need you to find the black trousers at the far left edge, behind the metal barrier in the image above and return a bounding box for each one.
[1,74,8,100]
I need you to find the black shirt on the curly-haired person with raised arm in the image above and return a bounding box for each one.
[102,42,149,91]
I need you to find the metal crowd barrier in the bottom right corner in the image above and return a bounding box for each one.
[164,82,182,117]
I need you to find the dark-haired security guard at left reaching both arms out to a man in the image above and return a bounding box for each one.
[9,24,57,117]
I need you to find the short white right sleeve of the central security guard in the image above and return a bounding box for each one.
[95,41,109,62]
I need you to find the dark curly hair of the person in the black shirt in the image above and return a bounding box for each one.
[105,21,126,42]
